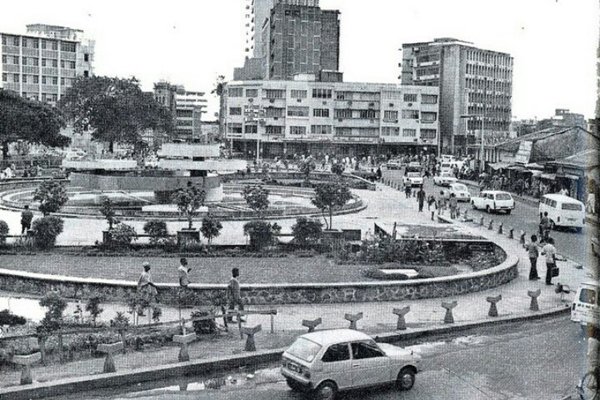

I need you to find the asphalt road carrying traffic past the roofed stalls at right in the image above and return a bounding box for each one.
[383,170,592,265]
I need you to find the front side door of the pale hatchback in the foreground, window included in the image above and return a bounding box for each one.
[350,341,391,387]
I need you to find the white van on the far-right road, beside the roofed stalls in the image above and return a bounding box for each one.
[539,194,585,232]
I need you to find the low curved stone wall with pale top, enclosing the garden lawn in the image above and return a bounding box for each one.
[0,252,518,305]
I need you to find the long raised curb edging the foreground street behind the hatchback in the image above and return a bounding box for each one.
[0,305,570,400]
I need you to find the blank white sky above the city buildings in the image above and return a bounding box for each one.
[0,0,599,119]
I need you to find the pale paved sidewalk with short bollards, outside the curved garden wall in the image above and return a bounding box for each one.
[0,184,590,387]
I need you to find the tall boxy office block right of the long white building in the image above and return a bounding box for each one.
[401,38,513,154]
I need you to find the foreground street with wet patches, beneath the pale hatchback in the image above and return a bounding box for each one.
[54,316,586,400]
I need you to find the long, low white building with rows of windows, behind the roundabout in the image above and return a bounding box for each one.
[220,76,439,157]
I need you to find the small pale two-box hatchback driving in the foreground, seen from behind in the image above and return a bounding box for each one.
[281,329,421,399]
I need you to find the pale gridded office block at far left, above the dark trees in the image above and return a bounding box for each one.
[0,24,94,103]
